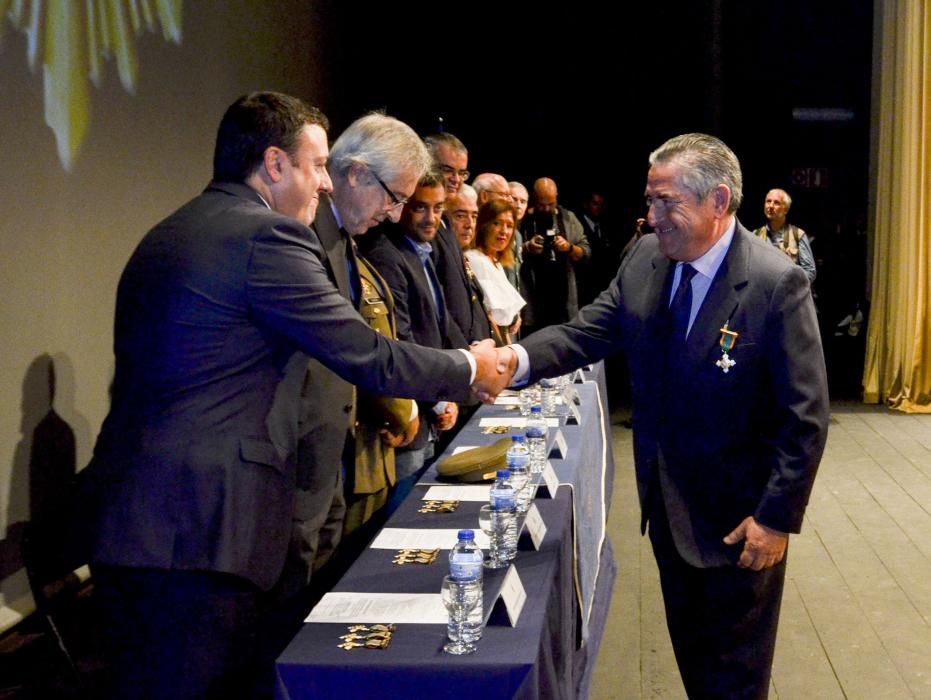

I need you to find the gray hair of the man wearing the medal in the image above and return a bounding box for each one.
[650,134,743,214]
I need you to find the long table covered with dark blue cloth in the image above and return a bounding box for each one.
[277,366,615,700]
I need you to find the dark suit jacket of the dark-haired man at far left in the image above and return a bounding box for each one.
[79,183,470,589]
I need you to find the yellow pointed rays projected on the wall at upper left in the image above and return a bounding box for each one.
[0,0,182,170]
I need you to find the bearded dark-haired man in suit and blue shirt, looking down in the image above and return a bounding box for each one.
[359,170,462,513]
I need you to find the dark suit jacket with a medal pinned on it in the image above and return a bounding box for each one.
[522,223,828,566]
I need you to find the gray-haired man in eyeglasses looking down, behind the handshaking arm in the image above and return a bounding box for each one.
[280,113,431,595]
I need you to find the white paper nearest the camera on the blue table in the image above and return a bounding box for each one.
[304,591,448,625]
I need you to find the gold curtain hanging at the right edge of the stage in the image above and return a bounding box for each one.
[863,0,931,413]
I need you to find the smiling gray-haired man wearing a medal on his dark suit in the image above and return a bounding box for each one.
[500,134,828,698]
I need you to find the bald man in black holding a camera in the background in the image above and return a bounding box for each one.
[520,177,591,332]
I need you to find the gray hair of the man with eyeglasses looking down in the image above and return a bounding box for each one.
[329,112,433,180]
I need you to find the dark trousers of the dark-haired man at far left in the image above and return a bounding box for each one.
[93,565,272,700]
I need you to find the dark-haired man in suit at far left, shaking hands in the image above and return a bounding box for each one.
[78,93,506,699]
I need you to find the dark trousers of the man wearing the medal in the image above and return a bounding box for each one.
[650,506,786,700]
